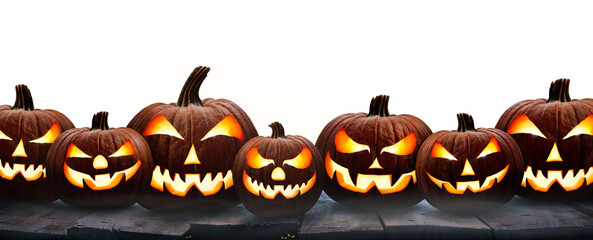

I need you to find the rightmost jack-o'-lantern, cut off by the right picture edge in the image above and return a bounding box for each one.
[496,79,593,200]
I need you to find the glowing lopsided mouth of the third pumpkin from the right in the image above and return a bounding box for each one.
[325,153,416,194]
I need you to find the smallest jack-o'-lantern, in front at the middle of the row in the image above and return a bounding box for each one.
[233,122,323,217]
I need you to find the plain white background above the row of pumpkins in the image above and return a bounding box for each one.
[0,0,593,142]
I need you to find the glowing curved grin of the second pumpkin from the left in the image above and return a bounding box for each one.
[64,160,142,190]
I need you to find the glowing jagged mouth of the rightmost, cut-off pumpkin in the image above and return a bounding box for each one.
[521,166,593,192]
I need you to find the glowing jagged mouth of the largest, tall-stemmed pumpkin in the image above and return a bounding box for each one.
[150,165,233,197]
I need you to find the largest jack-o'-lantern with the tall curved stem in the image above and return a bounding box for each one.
[128,67,257,211]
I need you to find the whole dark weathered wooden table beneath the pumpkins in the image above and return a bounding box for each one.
[0,194,593,240]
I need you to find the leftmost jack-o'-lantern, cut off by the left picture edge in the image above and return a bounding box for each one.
[0,85,74,203]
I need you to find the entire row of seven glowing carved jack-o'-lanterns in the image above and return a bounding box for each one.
[0,67,593,216]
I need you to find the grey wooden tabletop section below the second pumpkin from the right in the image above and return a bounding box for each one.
[379,201,492,239]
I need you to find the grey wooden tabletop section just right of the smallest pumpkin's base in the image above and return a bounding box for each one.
[299,193,385,239]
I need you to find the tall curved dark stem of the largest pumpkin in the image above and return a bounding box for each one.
[177,66,210,107]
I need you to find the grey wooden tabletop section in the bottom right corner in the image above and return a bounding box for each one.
[476,197,593,239]
